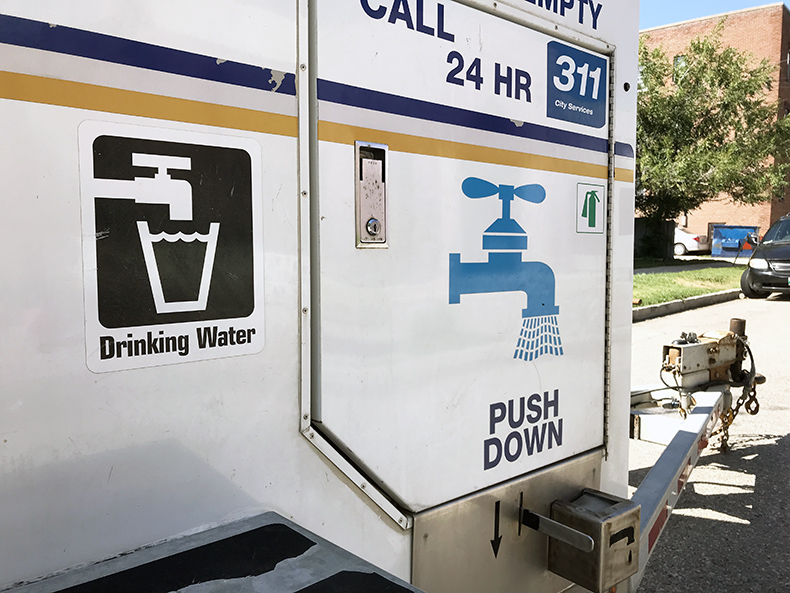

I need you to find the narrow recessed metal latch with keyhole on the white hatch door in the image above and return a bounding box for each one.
[354,142,387,249]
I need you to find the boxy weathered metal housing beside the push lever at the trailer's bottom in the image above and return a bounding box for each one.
[549,489,641,593]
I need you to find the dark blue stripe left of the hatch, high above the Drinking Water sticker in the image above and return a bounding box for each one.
[0,15,296,96]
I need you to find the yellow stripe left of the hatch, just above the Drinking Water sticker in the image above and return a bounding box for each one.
[0,72,298,137]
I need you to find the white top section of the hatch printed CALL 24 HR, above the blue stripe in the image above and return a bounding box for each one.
[318,0,608,138]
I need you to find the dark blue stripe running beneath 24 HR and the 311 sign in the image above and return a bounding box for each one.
[318,79,633,156]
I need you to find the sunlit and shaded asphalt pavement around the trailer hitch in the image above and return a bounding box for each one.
[629,294,790,593]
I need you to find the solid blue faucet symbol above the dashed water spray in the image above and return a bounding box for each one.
[450,177,559,318]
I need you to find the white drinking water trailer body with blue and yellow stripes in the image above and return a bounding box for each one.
[0,0,716,593]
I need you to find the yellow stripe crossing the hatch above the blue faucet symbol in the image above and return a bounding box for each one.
[318,121,633,181]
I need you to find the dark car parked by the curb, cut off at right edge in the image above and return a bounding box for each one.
[741,214,790,299]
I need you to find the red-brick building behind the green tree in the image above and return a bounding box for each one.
[641,3,790,237]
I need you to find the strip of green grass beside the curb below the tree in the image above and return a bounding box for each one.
[634,266,744,306]
